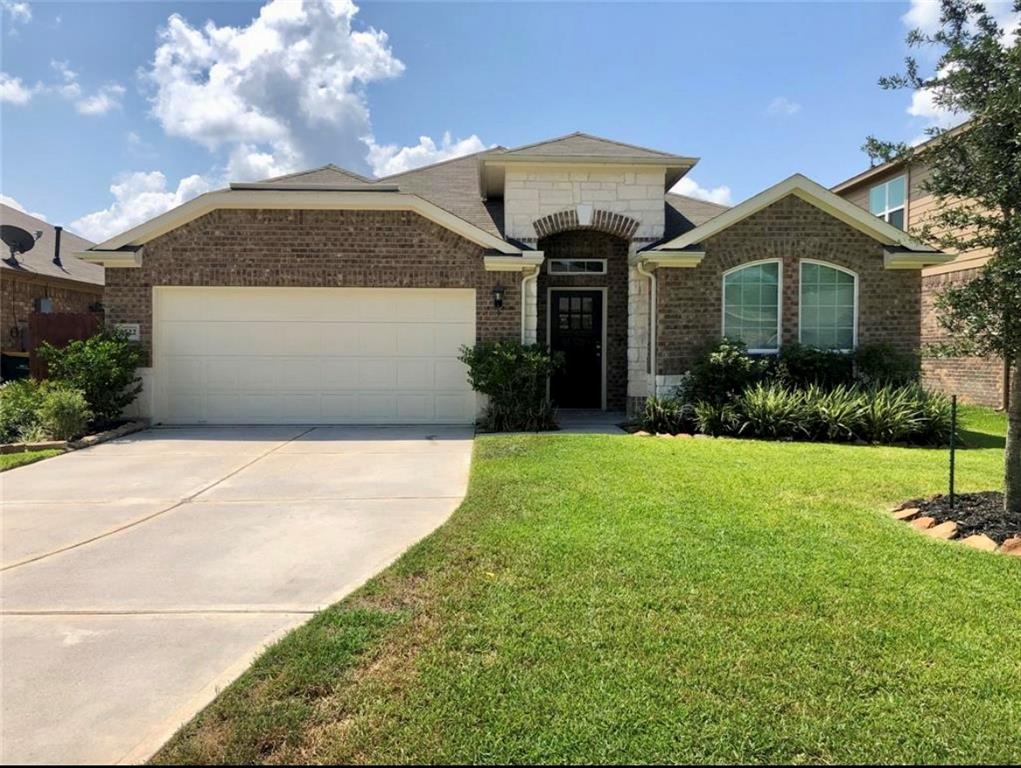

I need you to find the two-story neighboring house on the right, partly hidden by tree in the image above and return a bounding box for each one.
[833,139,1008,407]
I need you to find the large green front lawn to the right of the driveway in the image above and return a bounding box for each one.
[156,410,1021,763]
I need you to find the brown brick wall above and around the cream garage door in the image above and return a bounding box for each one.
[106,209,521,361]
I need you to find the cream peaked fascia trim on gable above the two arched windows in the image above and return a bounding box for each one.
[646,174,941,256]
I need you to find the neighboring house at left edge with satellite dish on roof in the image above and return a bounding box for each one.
[0,204,103,378]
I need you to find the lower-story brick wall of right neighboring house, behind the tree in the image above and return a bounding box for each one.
[922,269,1007,407]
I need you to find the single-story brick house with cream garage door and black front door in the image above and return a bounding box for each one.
[77,134,946,423]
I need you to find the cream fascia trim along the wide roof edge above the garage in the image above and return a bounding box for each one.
[83,189,521,255]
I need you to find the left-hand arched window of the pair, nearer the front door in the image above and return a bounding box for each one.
[723,260,780,352]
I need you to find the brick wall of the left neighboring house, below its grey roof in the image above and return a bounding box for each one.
[0,270,103,351]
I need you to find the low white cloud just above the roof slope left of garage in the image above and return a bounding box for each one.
[69,171,211,242]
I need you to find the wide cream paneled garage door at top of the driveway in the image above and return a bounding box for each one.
[153,288,475,424]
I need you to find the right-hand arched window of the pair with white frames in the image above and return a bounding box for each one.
[799,260,858,351]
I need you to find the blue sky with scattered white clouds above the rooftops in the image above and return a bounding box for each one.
[0,0,1004,239]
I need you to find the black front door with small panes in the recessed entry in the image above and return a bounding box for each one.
[549,289,602,409]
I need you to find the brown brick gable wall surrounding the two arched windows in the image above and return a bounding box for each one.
[657,196,921,375]
